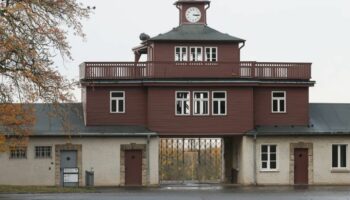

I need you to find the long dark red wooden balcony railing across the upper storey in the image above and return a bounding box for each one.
[80,62,311,80]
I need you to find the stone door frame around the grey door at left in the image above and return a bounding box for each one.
[55,144,83,186]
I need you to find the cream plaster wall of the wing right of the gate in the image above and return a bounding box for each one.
[257,136,350,185]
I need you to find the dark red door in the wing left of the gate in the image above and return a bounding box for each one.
[125,150,142,186]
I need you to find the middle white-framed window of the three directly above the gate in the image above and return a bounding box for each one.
[193,92,209,115]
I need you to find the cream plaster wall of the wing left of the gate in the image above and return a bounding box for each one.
[0,138,159,186]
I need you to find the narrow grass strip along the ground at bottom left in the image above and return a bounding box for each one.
[0,185,96,193]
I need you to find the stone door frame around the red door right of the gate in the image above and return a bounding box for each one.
[289,142,314,185]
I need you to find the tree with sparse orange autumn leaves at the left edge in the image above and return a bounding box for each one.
[0,0,90,151]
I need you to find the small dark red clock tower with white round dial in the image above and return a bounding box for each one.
[174,0,210,25]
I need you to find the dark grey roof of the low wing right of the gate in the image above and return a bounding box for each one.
[252,103,350,135]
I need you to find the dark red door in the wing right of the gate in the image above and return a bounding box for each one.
[294,149,309,185]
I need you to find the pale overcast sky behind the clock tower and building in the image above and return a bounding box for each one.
[56,0,350,103]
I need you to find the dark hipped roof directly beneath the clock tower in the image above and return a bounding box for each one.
[148,24,245,43]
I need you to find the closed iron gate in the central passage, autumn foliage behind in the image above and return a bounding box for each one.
[159,138,223,183]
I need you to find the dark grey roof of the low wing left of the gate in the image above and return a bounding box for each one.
[1,103,155,136]
